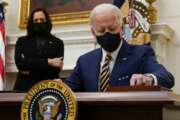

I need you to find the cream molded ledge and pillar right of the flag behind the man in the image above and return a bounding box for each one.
[151,24,175,66]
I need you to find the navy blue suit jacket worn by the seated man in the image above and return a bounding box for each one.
[65,42,174,91]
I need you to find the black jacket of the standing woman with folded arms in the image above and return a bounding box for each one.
[14,35,64,91]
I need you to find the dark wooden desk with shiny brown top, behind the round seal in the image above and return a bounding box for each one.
[0,87,177,120]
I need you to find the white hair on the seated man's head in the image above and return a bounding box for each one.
[89,3,123,26]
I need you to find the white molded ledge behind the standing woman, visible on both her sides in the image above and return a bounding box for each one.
[6,27,95,72]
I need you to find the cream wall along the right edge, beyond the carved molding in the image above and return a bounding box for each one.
[156,0,180,93]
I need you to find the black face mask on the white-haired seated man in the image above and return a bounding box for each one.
[96,32,121,52]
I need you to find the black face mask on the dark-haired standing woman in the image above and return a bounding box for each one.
[33,23,49,35]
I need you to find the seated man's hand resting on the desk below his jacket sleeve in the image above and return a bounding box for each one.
[130,74,154,86]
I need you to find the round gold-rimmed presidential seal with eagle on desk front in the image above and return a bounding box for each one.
[21,80,77,120]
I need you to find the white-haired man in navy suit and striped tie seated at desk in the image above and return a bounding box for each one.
[65,4,174,92]
